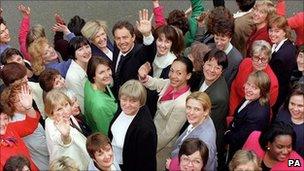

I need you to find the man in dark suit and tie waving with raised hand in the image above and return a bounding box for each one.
[112,10,154,97]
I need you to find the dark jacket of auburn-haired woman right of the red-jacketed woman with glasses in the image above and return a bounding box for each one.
[269,40,297,115]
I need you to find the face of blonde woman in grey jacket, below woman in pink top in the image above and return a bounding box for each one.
[186,99,209,127]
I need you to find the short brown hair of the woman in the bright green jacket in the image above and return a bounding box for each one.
[87,56,111,83]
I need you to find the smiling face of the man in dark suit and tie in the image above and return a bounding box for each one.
[114,27,135,53]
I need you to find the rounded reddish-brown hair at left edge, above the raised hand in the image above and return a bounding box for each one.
[0,62,27,86]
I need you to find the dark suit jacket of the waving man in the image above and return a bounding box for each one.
[112,43,155,97]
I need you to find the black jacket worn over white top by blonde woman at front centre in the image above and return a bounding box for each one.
[108,106,157,171]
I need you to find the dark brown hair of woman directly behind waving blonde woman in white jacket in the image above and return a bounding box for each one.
[39,68,60,92]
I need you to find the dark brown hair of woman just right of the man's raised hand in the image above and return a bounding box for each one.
[156,25,184,55]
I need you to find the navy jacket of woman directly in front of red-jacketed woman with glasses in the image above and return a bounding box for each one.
[224,100,270,156]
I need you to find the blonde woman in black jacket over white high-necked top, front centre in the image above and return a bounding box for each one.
[108,80,157,171]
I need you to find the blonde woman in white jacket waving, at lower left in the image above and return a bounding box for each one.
[44,90,90,170]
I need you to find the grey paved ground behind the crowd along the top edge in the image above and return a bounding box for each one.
[0,0,303,48]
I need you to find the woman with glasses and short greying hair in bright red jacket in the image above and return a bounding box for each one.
[227,40,279,124]
